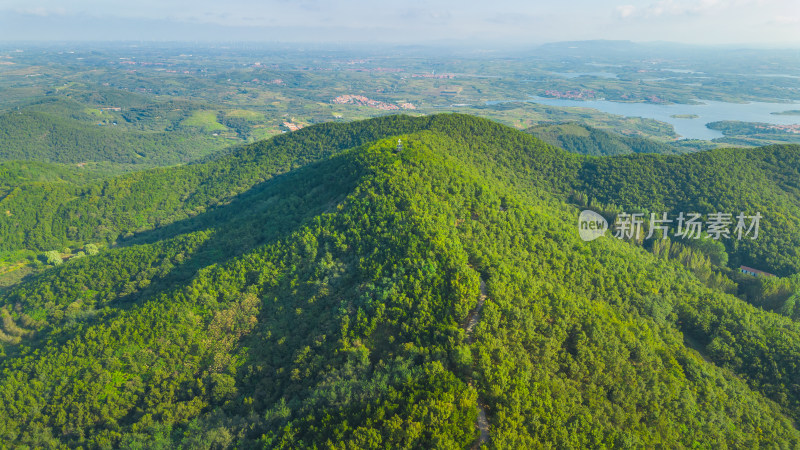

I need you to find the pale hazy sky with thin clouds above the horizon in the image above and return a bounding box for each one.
[0,0,800,47]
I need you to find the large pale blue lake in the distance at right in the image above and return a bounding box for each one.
[504,97,800,140]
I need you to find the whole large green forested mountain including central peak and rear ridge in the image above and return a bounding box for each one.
[0,115,800,449]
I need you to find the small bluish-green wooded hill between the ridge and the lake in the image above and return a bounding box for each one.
[525,123,685,156]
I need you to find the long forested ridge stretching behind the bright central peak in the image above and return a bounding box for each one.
[0,115,800,275]
